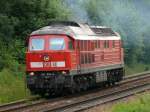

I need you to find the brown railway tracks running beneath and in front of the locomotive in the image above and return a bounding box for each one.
[0,72,150,112]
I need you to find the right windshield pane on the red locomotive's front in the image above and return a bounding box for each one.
[49,38,65,50]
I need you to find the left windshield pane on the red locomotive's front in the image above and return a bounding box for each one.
[30,39,44,51]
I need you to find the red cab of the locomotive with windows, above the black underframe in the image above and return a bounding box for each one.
[27,35,74,72]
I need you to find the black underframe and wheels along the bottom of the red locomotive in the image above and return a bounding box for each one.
[27,67,124,95]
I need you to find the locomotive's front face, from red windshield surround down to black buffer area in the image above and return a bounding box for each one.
[26,35,74,94]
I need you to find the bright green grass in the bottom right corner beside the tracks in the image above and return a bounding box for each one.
[112,93,150,112]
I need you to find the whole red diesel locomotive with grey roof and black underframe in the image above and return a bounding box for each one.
[26,21,124,95]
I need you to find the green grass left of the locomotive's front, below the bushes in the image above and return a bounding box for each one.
[0,69,29,104]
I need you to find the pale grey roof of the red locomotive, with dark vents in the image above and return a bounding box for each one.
[31,21,120,40]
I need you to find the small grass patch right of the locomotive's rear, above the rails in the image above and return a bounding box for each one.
[125,63,150,75]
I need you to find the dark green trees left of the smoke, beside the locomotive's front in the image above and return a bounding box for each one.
[0,0,70,72]
